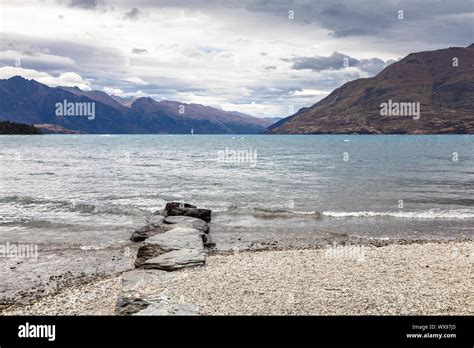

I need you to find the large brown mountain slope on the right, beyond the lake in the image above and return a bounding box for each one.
[266,44,474,134]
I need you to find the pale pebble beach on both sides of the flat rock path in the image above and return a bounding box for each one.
[0,240,474,315]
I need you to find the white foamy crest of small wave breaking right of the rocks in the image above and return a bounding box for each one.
[323,210,474,219]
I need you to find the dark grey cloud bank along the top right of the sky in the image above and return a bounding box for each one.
[142,0,473,46]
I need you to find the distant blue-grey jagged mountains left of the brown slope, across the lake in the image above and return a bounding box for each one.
[0,76,271,134]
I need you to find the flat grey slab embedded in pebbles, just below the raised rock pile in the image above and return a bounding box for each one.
[122,269,176,298]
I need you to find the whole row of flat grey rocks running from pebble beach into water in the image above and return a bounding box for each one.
[116,203,209,315]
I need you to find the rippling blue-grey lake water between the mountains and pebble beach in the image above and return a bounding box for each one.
[0,135,474,302]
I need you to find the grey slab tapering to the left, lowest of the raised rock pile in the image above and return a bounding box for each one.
[142,249,206,271]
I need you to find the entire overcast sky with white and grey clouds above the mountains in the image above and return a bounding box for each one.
[0,0,474,117]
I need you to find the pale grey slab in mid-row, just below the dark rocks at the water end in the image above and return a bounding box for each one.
[146,227,204,251]
